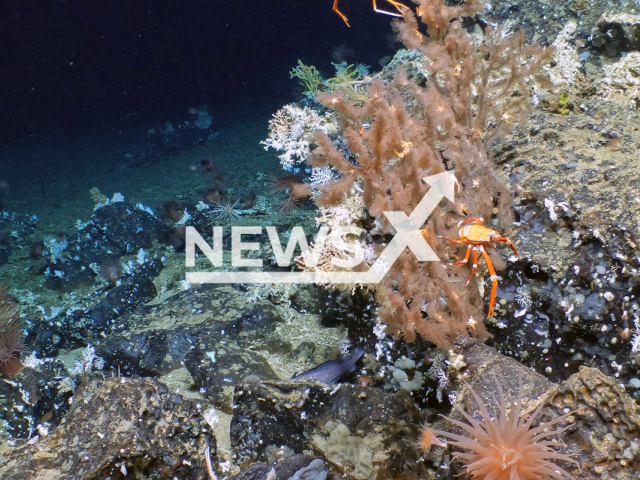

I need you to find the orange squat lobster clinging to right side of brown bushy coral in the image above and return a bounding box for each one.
[440,217,520,318]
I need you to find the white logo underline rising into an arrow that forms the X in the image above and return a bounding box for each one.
[186,171,457,284]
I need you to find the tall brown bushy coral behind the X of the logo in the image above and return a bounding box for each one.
[309,0,550,347]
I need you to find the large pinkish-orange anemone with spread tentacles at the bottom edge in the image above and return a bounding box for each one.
[431,379,579,480]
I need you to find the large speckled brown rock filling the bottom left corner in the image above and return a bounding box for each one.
[0,378,217,480]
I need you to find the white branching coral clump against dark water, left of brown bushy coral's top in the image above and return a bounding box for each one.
[261,105,338,170]
